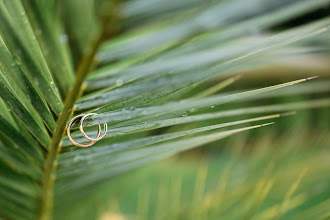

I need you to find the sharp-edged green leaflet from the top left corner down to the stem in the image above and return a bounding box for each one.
[0,0,63,114]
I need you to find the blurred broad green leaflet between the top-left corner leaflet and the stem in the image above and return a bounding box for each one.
[23,1,74,98]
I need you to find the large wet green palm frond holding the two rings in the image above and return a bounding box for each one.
[0,0,330,220]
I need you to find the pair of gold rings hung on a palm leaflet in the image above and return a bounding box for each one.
[66,113,108,147]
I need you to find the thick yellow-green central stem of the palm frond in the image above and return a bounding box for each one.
[39,0,120,216]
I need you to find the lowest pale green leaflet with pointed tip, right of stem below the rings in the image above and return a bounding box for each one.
[57,124,274,194]
